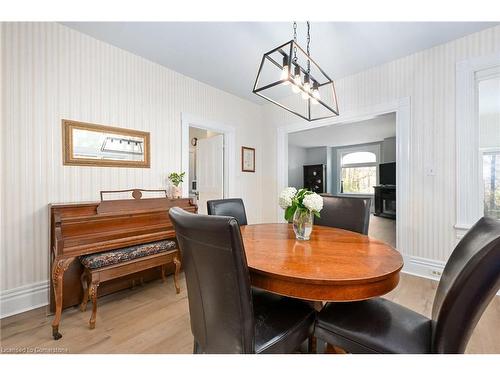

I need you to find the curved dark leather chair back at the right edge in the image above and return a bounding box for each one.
[432,218,500,353]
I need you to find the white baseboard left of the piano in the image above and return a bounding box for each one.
[0,280,49,318]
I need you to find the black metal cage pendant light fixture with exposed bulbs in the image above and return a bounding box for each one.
[253,22,339,121]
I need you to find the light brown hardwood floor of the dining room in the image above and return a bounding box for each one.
[0,274,500,353]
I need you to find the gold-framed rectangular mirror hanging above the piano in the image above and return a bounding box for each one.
[62,120,150,168]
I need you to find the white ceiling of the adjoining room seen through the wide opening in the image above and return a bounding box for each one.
[288,113,396,148]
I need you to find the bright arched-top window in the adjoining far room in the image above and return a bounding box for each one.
[338,145,380,195]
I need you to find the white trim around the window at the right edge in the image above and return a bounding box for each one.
[455,53,500,238]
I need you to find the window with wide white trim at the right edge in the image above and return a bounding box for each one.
[455,53,500,238]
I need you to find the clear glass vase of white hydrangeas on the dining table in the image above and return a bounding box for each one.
[279,187,323,240]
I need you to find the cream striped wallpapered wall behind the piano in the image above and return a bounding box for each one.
[0,23,263,314]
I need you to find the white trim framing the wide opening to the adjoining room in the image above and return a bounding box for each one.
[276,97,413,254]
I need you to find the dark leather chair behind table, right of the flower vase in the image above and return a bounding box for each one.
[314,194,372,234]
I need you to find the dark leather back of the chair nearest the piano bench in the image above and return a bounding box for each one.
[169,207,255,353]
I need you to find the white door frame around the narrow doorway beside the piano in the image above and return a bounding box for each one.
[181,112,237,198]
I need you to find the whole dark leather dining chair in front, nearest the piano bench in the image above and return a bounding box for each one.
[169,207,315,353]
